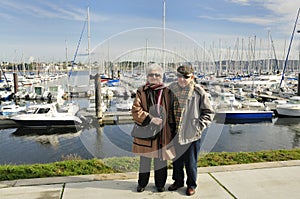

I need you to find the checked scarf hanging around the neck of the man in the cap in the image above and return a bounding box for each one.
[171,81,195,132]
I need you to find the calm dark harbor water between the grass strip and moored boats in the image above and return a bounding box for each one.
[0,71,300,165]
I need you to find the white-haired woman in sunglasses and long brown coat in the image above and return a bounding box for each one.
[132,64,175,192]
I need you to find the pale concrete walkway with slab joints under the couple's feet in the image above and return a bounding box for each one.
[0,160,300,199]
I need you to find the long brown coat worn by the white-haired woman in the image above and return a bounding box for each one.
[132,86,175,160]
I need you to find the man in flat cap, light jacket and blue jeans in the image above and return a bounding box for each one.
[168,65,214,196]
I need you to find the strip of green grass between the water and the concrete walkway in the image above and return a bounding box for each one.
[0,148,300,181]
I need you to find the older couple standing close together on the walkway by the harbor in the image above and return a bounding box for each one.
[132,64,214,196]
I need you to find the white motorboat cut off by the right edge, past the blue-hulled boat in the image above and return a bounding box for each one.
[276,96,300,117]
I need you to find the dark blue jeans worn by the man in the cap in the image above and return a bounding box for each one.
[172,139,201,189]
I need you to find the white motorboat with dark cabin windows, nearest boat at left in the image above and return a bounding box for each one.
[10,103,82,128]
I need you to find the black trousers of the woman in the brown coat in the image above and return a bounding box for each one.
[138,156,168,188]
